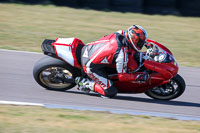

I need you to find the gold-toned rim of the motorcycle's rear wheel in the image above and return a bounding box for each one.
[39,67,73,89]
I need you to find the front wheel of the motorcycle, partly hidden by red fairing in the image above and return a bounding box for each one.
[145,74,185,100]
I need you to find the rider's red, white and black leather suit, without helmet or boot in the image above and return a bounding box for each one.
[81,31,141,97]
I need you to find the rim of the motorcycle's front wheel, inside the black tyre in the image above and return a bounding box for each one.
[149,79,180,99]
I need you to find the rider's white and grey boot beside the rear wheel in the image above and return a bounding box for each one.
[75,77,94,94]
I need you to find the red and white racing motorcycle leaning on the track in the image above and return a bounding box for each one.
[33,38,185,100]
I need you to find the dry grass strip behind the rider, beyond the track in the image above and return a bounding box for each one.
[0,4,200,67]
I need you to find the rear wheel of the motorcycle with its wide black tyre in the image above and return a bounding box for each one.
[33,56,78,91]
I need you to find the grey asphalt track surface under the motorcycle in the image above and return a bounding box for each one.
[0,50,200,119]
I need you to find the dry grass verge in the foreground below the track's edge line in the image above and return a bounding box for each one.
[0,105,200,133]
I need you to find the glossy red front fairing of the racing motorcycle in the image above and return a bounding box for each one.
[110,40,178,93]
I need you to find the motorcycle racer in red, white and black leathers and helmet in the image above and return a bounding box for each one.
[75,25,148,97]
